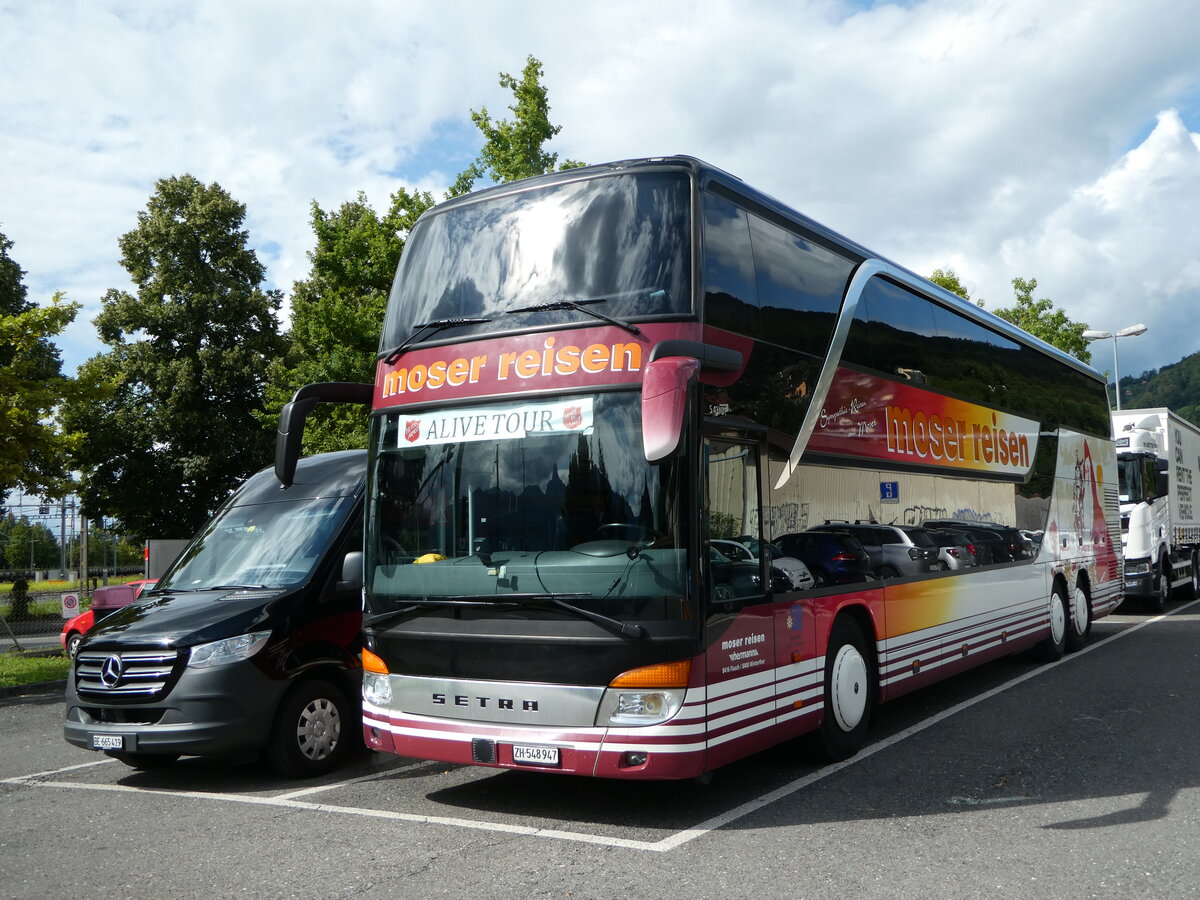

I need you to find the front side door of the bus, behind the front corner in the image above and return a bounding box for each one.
[701,430,775,766]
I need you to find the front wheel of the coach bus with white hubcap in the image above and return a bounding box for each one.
[821,616,875,761]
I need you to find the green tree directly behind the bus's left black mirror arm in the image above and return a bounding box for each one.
[263,188,433,454]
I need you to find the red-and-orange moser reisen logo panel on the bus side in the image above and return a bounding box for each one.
[808,368,1039,478]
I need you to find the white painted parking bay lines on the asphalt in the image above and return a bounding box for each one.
[0,600,1185,853]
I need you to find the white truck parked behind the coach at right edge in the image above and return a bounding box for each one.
[1112,408,1200,612]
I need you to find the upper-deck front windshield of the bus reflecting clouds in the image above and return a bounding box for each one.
[379,170,691,352]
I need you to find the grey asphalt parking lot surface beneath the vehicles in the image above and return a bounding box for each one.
[0,604,1200,899]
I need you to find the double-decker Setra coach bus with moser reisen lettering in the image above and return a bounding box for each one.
[285,157,1122,779]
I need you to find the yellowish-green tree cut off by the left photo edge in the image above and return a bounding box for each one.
[0,234,88,499]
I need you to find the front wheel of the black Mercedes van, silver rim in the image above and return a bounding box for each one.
[266,678,350,778]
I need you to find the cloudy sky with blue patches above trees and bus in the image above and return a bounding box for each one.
[0,0,1200,374]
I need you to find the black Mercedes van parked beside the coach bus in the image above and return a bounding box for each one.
[64,450,366,776]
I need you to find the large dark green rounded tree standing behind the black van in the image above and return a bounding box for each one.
[64,175,283,538]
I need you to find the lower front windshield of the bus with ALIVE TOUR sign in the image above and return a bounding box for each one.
[366,392,686,620]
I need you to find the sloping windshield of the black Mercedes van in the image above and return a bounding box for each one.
[155,497,354,592]
